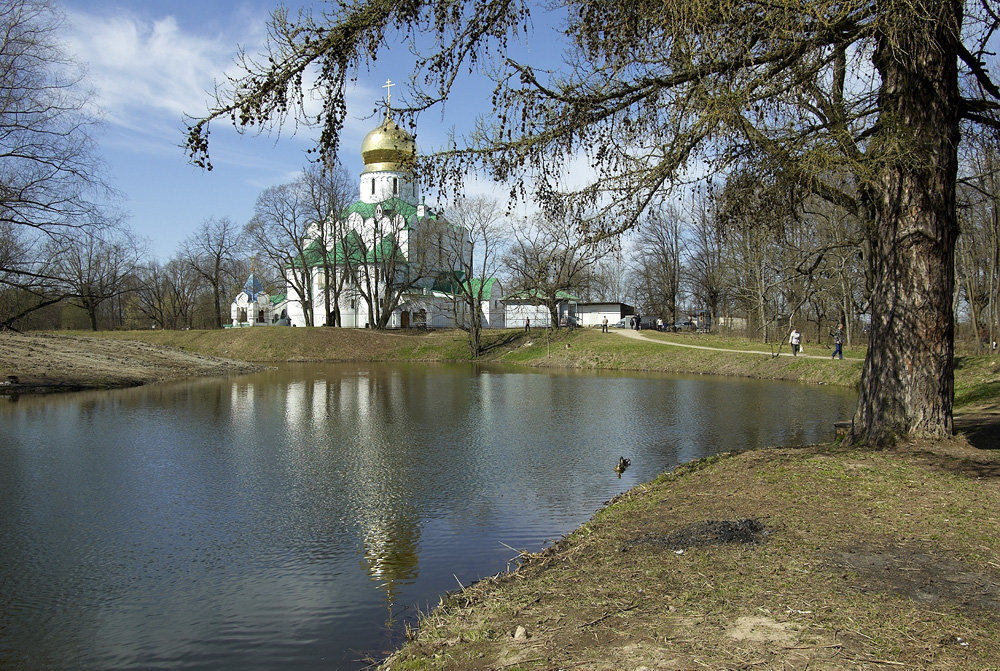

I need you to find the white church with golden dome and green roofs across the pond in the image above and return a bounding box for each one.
[232,89,504,328]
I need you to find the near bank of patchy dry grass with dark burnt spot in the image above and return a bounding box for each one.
[383,443,1000,671]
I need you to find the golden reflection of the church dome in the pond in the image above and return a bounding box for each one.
[361,502,420,629]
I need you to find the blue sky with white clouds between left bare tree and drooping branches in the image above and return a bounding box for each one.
[61,0,551,261]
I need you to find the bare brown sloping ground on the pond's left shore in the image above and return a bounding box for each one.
[0,332,259,394]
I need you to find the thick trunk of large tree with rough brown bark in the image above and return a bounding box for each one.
[852,0,962,446]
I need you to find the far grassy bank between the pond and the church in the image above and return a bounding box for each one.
[66,328,1000,406]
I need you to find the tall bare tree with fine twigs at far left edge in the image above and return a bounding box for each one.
[0,0,111,327]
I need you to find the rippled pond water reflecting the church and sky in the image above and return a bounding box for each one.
[0,365,856,669]
